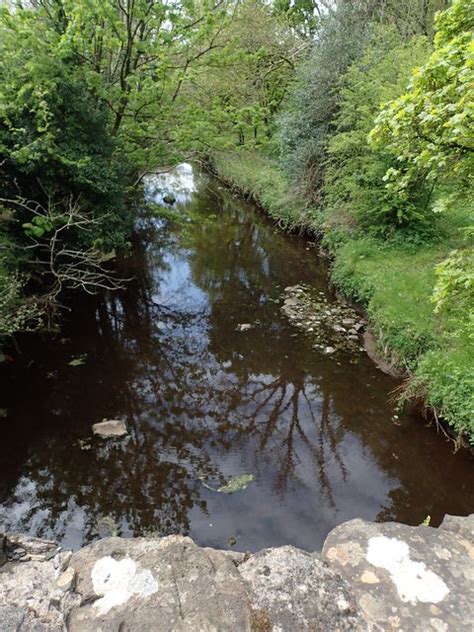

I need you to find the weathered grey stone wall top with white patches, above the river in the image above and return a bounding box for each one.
[0,514,474,632]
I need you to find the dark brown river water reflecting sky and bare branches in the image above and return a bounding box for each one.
[0,166,474,551]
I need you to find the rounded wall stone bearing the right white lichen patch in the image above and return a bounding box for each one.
[323,520,474,632]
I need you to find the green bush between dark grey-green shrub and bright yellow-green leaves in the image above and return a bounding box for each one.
[324,25,429,240]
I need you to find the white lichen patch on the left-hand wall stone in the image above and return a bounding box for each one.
[91,555,158,614]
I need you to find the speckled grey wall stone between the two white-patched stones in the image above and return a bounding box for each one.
[239,546,378,632]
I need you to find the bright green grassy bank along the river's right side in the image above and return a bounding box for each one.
[214,153,474,443]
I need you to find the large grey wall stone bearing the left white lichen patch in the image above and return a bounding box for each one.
[68,536,251,632]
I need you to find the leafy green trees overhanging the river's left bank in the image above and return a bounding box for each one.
[0,0,258,340]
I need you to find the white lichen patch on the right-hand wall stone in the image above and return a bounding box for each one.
[367,536,449,605]
